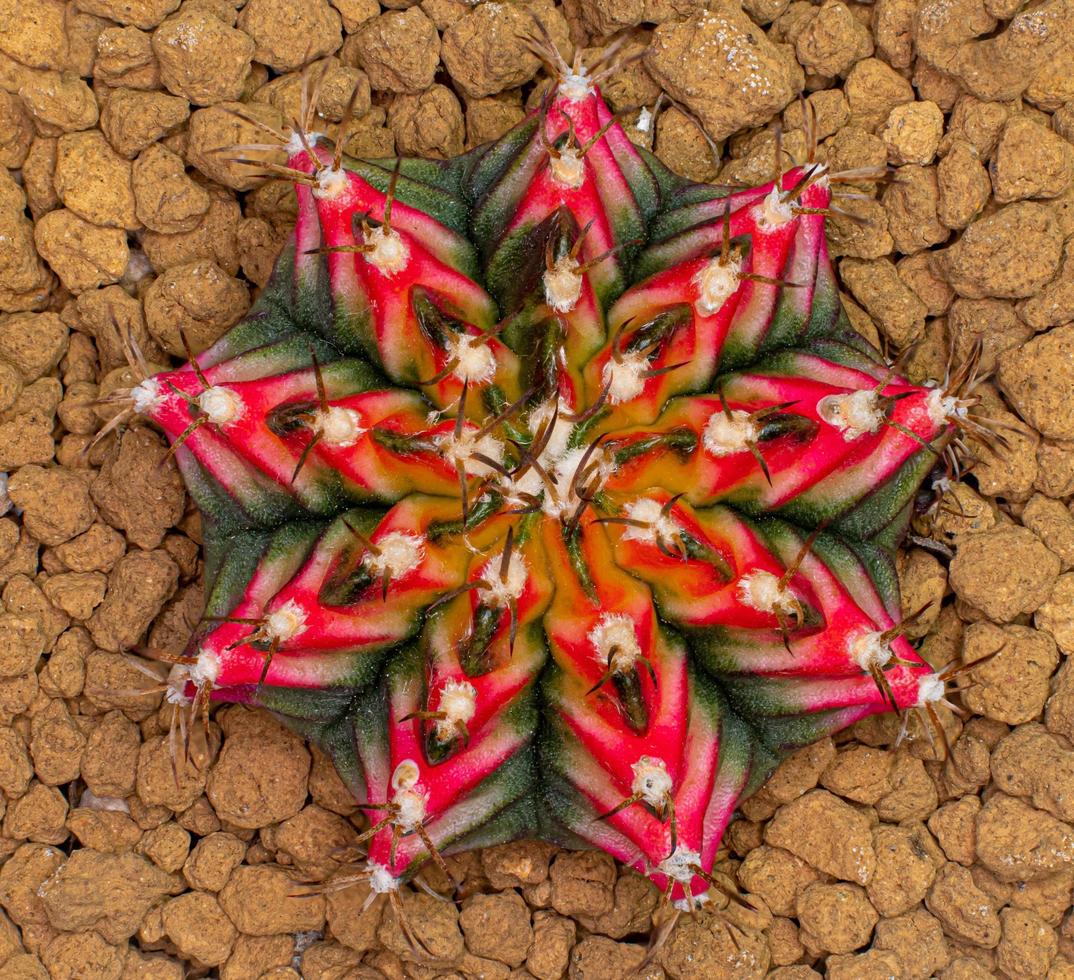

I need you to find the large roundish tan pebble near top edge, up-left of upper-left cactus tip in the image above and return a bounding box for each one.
[153,10,256,105]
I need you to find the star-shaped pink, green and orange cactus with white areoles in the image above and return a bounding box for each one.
[113,51,973,905]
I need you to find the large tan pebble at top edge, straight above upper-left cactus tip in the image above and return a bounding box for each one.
[238,0,343,72]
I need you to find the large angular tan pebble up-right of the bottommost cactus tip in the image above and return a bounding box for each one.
[765,790,876,884]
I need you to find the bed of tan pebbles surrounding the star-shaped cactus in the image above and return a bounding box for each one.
[0,0,1074,980]
